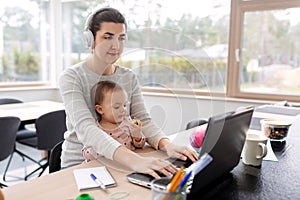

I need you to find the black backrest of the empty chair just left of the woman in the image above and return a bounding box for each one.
[35,110,67,151]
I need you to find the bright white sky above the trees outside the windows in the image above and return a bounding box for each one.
[0,0,300,25]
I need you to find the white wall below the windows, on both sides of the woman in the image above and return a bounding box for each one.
[1,88,269,134]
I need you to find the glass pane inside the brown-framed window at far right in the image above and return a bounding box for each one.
[240,8,300,94]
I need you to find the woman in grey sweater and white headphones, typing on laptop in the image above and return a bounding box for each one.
[59,7,197,178]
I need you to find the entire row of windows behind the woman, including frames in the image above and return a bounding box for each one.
[0,0,300,102]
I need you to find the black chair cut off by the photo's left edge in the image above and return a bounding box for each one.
[0,117,21,188]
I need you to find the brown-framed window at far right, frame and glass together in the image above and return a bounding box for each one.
[228,1,300,101]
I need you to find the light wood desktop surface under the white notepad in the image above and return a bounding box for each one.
[3,148,163,200]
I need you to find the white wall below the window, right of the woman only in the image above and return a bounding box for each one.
[144,93,264,134]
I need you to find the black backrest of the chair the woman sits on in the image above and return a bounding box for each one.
[49,141,64,173]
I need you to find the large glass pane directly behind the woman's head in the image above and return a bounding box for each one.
[62,0,230,93]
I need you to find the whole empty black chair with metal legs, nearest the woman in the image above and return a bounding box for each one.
[19,110,67,180]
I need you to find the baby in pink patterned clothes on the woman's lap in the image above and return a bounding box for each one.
[82,81,145,162]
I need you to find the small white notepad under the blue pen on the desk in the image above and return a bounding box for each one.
[73,166,117,190]
